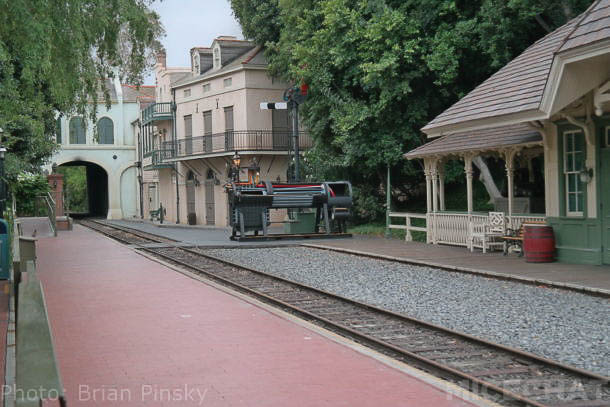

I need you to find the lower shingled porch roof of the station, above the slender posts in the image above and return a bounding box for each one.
[404,124,542,159]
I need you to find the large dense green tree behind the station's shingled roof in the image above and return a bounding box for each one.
[231,0,590,220]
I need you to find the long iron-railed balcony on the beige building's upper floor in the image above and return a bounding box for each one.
[164,130,312,158]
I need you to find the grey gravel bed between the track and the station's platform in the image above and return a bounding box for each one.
[206,247,610,376]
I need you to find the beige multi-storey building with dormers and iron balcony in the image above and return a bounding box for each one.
[139,36,311,227]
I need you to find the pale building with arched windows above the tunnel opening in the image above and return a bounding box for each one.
[49,78,154,219]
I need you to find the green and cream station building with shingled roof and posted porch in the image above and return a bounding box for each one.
[405,0,610,264]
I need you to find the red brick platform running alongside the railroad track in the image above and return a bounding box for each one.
[37,225,486,407]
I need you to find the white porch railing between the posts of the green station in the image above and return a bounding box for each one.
[427,212,546,247]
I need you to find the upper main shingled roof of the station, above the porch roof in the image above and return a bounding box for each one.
[422,0,610,133]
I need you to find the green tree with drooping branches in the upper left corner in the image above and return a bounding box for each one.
[0,0,163,180]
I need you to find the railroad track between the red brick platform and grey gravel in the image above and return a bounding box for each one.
[82,225,610,407]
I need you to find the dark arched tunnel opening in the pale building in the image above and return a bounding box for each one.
[58,161,108,218]
